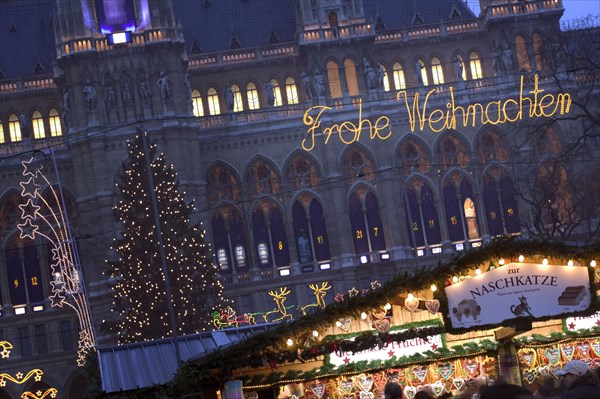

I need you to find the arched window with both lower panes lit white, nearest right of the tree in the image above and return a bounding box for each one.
[212,206,250,274]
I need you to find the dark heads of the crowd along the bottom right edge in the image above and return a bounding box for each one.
[385,360,600,399]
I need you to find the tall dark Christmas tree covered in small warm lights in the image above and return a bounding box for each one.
[108,133,225,343]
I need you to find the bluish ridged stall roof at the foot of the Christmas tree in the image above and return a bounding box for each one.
[98,324,274,393]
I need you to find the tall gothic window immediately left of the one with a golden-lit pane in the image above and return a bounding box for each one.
[406,180,442,247]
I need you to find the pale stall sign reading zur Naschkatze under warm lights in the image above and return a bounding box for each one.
[445,263,591,328]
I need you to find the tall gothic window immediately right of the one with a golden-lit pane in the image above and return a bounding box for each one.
[483,168,520,236]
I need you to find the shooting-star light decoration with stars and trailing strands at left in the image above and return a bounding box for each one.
[17,157,95,367]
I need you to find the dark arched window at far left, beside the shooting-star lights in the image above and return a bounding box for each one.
[5,237,44,307]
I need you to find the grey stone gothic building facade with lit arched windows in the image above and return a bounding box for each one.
[0,0,600,398]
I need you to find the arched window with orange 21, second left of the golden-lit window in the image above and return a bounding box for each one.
[349,187,386,255]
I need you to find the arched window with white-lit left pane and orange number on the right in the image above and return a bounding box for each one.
[252,201,290,268]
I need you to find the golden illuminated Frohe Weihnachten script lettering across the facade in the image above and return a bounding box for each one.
[302,75,572,151]
